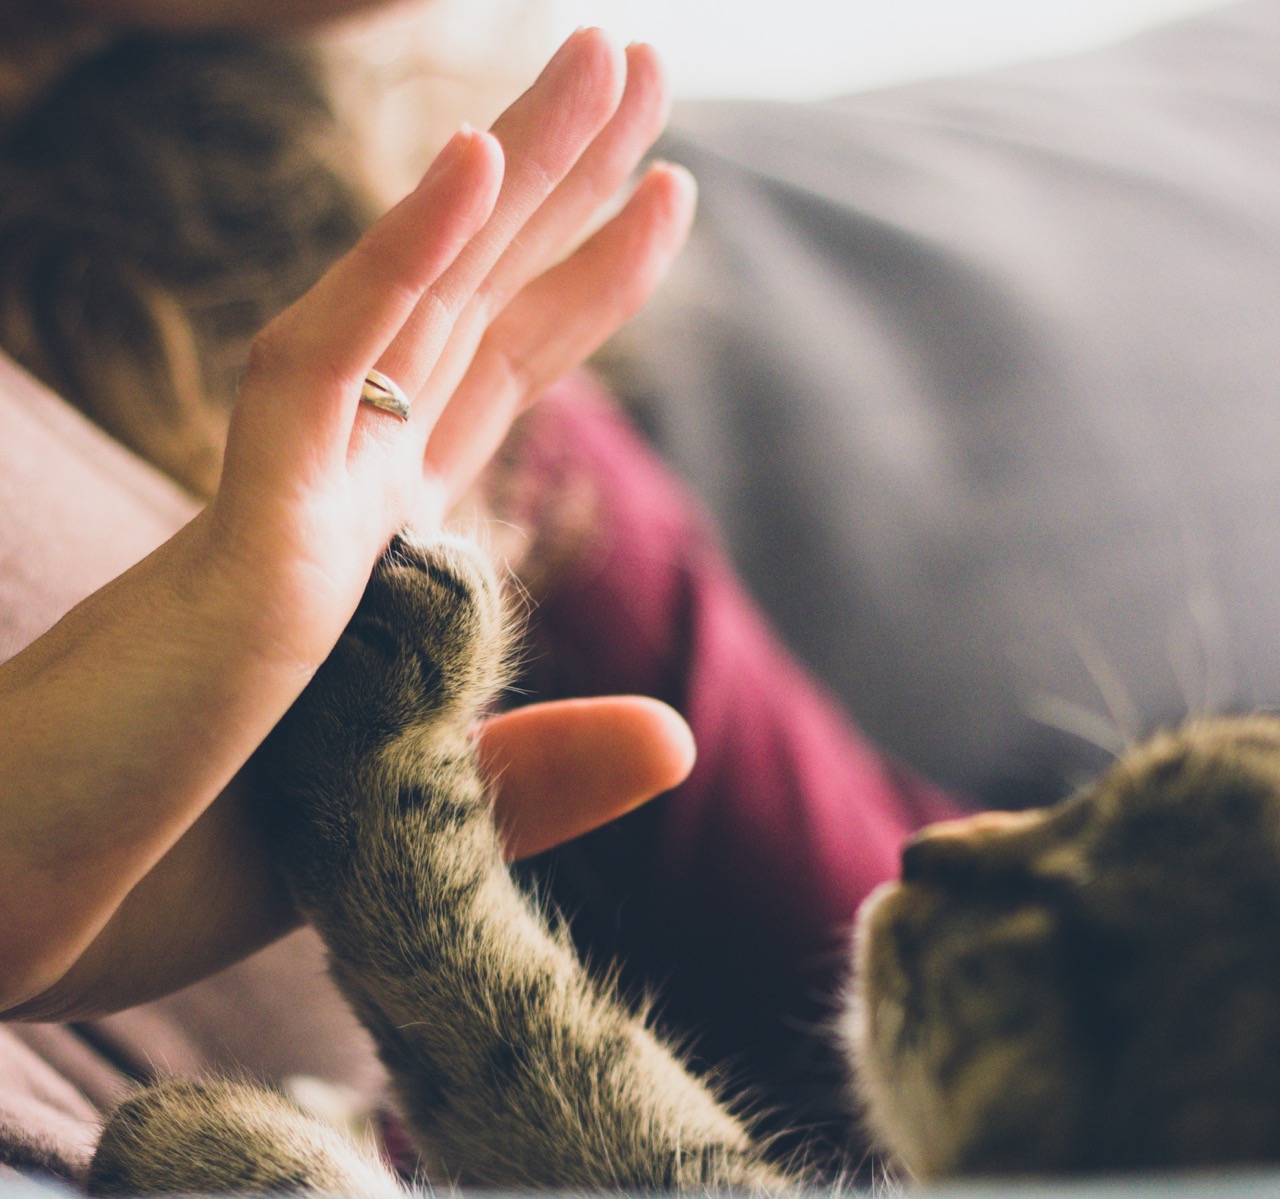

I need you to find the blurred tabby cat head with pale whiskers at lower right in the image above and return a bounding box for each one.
[845,717,1280,1176]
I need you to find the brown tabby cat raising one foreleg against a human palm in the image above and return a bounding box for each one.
[77,537,1280,1194]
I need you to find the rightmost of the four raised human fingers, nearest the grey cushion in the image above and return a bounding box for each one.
[424,163,698,499]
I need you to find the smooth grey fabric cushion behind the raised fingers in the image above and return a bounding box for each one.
[613,0,1280,804]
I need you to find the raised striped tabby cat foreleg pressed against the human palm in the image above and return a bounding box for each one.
[259,544,785,1190]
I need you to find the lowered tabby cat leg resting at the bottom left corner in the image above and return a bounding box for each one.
[86,1083,404,1199]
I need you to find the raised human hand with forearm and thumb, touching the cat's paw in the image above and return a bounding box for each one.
[0,29,692,1019]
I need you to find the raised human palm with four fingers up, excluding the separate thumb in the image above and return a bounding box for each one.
[201,31,692,672]
